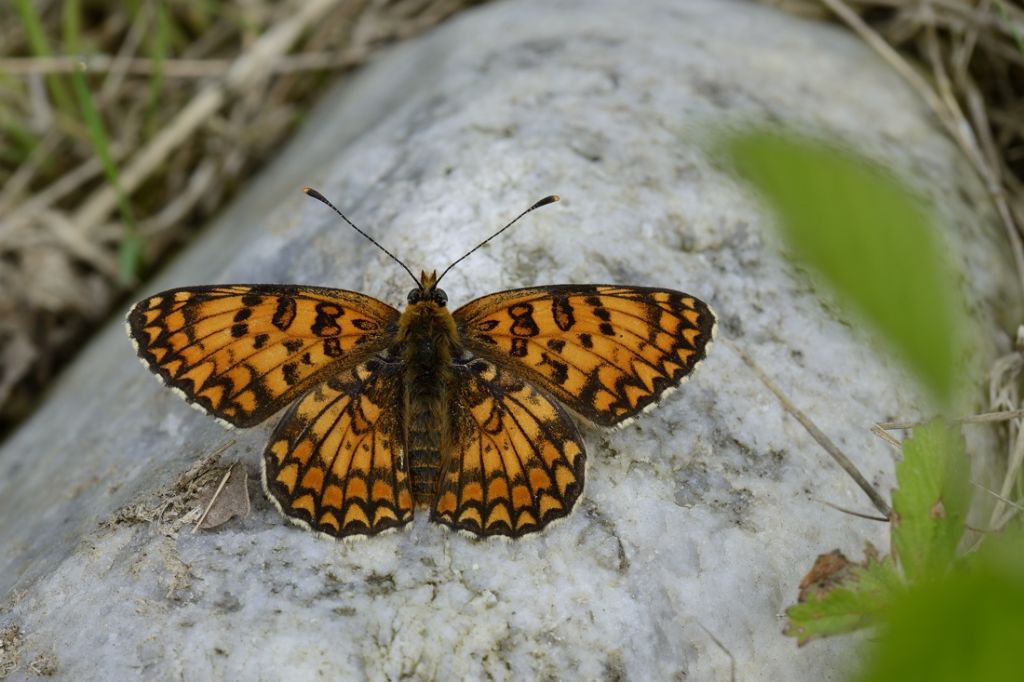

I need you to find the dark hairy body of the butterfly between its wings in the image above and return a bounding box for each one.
[396,300,459,506]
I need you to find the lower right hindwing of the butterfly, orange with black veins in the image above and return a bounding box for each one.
[430,358,587,538]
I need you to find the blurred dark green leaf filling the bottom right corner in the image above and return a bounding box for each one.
[859,534,1024,682]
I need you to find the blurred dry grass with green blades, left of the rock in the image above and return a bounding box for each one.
[0,0,487,433]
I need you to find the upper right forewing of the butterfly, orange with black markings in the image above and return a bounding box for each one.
[453,285,715,426]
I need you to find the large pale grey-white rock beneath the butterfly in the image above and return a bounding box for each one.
[0,0,1013,680]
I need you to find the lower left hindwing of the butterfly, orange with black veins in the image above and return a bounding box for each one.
[263,358,413,538]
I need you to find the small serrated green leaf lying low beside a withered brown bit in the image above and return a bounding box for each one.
[785,557,903,645]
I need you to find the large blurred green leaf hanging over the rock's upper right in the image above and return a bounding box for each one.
[721,131,961,404]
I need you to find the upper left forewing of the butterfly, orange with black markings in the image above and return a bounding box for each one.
[127,285,399,426]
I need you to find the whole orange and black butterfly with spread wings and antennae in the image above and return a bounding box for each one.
[127,188,715,538]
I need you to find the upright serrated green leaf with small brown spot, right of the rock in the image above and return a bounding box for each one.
[892,420,971,583]
